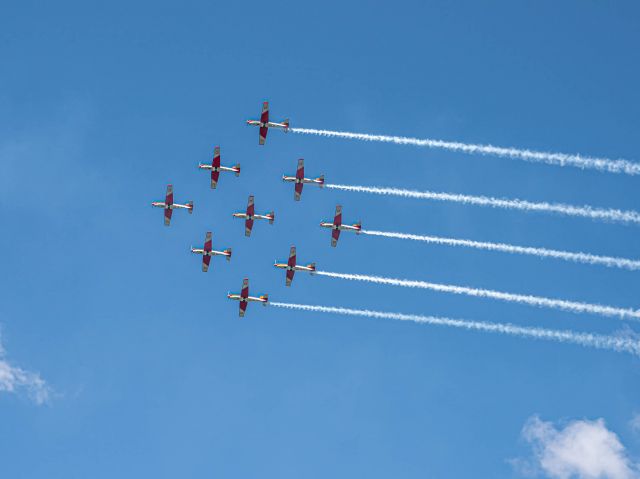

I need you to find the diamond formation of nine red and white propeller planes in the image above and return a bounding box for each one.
[151,101,362,317]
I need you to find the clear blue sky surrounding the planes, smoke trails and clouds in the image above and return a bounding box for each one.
[0,1,640,478]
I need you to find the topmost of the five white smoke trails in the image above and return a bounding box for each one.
[289,128,640,175]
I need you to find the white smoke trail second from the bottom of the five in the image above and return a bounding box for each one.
[316,271,640,319]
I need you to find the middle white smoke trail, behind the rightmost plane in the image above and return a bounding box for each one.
[361,230,640,271]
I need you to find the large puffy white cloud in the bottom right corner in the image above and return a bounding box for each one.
[514,416,640,479]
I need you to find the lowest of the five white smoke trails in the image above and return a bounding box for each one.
[269,302,640,356]
